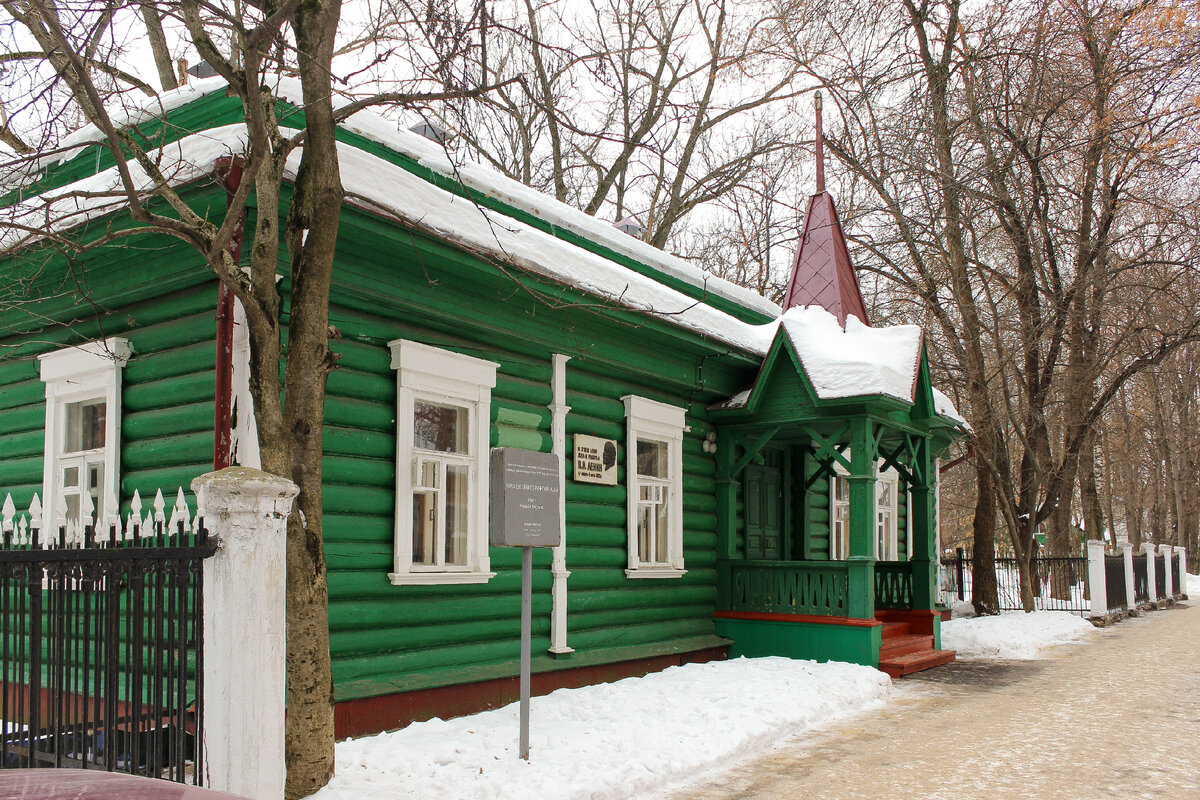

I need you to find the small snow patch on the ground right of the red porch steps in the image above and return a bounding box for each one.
[942,612,1096,660]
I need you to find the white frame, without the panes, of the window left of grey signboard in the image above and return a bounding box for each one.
[388,339,499,585]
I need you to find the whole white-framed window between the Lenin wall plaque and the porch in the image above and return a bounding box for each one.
[622,395,685,578]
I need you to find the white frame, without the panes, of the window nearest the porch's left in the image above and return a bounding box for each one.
[620,395,688,578]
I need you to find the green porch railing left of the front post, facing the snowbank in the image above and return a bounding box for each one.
[727,561,848,616]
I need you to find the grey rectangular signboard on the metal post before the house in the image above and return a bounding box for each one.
[492,447,563,547]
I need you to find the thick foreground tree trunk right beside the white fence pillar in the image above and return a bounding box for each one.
[284,0,344,799]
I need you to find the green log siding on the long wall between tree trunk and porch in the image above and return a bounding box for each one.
[325,283,719,699]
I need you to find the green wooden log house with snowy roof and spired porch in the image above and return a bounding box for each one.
[0,79,964,735]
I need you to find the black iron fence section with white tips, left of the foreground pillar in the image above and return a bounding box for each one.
[0,493,216,786]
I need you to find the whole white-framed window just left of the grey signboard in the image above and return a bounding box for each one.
[388,339,497,585]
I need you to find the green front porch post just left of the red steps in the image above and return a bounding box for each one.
[846,419,875,619]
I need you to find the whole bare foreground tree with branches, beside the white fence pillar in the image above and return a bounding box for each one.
[0,0,501,798]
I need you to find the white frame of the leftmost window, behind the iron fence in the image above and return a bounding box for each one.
[38,336,132,529]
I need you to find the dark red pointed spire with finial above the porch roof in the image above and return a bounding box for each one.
[784,92,870,327]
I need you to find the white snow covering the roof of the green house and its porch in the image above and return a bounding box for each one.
[0,79,966,426]
